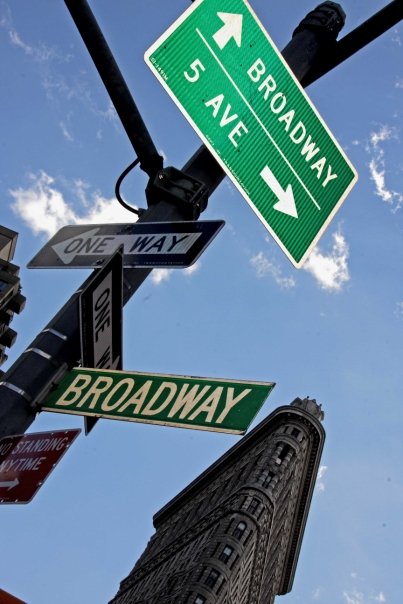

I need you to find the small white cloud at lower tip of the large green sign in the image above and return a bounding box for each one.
[303,228,350,292]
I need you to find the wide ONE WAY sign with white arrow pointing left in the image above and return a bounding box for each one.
[27,220,225,268]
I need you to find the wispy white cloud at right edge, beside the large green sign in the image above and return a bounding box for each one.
[367,125,403,211]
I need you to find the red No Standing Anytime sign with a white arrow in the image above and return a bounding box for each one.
[0,430,81,503]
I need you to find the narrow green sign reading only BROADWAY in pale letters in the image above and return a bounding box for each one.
[42,368,274,434]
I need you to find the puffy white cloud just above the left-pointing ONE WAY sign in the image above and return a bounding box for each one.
[10,171,136,236]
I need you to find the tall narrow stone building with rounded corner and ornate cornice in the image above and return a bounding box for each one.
[110,399,325,604]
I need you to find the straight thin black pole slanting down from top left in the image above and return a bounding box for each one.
[65,0,163,177]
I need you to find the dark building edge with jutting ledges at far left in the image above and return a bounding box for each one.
[0,226,26,365]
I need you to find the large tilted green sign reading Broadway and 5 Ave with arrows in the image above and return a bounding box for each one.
[145,0,357,267]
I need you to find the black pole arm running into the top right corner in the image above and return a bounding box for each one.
[301,0,403,86]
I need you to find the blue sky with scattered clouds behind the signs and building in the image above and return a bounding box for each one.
[0,0,403,604]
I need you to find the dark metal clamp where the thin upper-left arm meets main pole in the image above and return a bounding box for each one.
[146,167,208,220]
